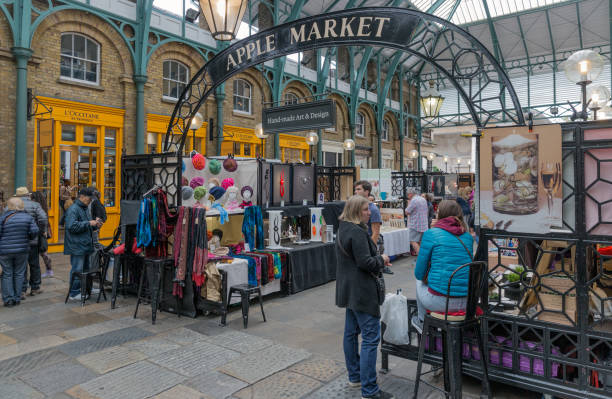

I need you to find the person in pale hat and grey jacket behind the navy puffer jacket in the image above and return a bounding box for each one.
[15,187,48,299]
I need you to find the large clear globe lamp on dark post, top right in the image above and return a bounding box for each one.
[563,50,604,121]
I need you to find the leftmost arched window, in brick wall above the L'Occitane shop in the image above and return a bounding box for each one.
[60,33,100,84]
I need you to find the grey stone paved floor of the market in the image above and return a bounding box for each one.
[0,255,540,399]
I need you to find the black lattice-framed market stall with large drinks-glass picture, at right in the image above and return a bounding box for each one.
[382,122,612,399]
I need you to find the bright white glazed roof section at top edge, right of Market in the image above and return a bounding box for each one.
[412,0,567,25]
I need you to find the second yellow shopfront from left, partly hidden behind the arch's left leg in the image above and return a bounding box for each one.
[145,114,208,154]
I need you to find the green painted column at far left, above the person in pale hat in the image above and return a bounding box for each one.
[11,47,32,188]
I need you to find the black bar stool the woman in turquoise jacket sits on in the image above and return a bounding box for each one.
[408,261,491,399]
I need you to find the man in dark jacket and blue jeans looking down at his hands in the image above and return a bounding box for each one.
[64,188,102,300]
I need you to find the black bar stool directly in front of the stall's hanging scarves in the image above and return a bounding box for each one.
[134,258,181,324]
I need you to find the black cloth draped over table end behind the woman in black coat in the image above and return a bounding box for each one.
[287,243,336,294]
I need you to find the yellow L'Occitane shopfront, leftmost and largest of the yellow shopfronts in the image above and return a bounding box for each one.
[32,97,125,252]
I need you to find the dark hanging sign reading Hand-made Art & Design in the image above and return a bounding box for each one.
[261,100,336,134]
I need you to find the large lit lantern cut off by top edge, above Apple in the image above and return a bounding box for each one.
[200,0,247,41]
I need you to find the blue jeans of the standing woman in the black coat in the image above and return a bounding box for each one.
[343,309,380,397]
